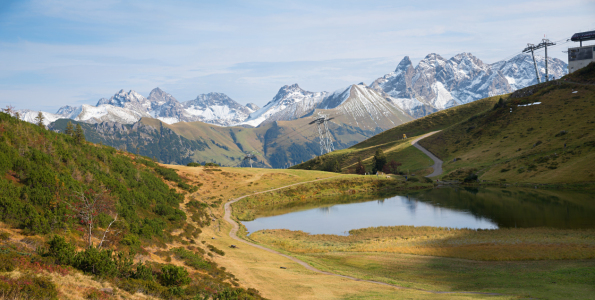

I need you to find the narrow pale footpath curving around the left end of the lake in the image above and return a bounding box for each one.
[223,176,505,296]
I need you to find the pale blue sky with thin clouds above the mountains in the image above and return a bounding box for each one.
[0,0,595,112]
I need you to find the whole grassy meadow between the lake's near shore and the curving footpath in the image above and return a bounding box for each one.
[249,226,595,299]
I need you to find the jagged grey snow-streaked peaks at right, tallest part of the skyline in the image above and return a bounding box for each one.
[371,52,567,117]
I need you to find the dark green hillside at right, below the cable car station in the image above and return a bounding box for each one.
[420,73,595,183]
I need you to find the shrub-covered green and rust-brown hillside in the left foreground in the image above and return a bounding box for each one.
[0,113,260,299]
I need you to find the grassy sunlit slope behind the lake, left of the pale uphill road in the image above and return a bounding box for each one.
[294,97,498,174]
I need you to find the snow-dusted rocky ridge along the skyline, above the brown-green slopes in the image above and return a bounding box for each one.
[21,53,567,129]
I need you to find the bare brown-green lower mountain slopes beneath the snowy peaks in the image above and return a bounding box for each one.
[51,111,400,168]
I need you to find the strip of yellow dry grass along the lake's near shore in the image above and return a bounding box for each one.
[250,226,595,261]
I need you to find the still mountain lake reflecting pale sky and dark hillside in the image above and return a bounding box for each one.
[242,187,595,235]
